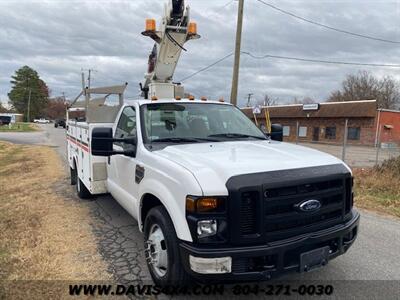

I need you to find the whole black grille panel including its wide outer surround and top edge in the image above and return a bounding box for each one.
[226,164,352,245]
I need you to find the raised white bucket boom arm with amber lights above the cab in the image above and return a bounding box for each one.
[141,0,200,99]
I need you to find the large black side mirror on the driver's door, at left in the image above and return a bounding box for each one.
[91,128,136,157]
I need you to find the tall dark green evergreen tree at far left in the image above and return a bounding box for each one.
[8,66,49,121]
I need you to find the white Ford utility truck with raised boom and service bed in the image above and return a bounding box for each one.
[67,0,359,286]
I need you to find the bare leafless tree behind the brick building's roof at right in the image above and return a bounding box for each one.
[328,71,400,109]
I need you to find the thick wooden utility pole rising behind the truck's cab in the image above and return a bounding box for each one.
[231,0,244,105]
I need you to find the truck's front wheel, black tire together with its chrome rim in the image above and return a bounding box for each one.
[144,206,191,287]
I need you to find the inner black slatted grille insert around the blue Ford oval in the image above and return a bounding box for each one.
[264,178,346,241]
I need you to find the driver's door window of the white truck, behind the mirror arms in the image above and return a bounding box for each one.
[114,106,137,151]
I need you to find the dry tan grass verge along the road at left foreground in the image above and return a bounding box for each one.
[0,142,111,298]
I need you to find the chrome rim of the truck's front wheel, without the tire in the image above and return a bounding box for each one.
[145,224,168,277]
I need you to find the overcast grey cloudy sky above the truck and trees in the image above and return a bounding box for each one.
[0,0,400,106]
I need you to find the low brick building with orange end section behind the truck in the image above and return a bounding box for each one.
[243,100,400,146]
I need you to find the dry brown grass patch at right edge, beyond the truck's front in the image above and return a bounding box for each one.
[354,157,400,217]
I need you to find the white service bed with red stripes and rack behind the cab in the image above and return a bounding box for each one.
[67,84,126,197]
